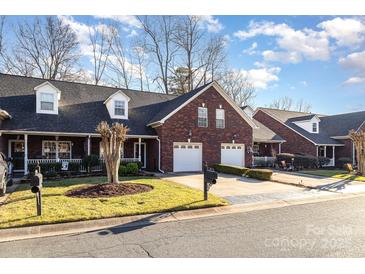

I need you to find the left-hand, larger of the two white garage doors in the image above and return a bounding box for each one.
[174,143,202,172]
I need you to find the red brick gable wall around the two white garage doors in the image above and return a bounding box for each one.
[156,87,253,172]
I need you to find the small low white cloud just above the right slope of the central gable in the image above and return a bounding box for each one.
[237,67,281,89]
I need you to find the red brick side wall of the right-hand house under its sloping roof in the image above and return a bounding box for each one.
[254,110,317,156]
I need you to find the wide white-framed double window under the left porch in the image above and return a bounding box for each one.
[42,141,72,159]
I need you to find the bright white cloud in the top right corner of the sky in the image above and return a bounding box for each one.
[318,17,365,46]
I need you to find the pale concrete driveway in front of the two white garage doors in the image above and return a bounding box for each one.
[163,173,308,204]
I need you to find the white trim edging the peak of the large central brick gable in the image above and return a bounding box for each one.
[147,82,257,128]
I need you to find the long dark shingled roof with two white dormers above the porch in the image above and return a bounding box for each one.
[0,74,176,135]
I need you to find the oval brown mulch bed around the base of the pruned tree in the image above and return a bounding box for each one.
[65,183,153,198]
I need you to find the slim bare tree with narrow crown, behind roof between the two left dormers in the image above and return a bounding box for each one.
[89,24,113,85]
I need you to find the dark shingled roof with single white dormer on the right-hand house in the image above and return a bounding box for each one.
[256,108,365,145]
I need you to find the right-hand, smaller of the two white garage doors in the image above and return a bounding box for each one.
[221,144,245,166]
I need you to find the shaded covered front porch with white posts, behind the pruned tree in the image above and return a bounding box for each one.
[0,132,159,174]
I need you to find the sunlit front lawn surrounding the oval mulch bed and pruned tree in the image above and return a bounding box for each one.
[0,177,228,228]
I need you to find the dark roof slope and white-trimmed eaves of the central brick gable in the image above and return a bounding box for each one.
[148,81,256,128]
